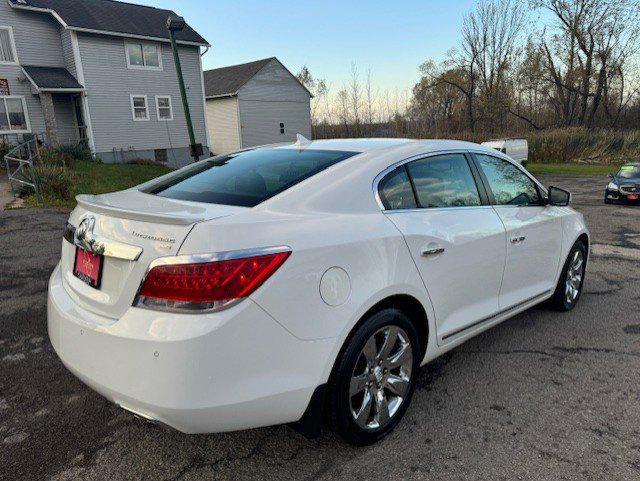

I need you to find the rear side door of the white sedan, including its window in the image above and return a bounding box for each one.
[378,153,506,342]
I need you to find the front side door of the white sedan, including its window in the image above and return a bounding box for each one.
[474,154,562,309]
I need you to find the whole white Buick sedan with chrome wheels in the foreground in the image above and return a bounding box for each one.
[48,139,589,445]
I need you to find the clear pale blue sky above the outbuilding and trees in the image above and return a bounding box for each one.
[129,0,474,93]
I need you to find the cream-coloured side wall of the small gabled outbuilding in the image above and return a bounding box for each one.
[206,97,241,154]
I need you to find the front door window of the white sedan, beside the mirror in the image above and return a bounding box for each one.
[476,154,541,205]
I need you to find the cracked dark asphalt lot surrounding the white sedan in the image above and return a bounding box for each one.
[0,176,640,481]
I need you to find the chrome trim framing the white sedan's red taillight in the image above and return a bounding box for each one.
[132,245,292,314]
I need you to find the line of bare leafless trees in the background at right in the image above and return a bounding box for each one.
[298,0,640,137]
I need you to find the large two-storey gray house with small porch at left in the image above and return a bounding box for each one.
[0,0,210,165]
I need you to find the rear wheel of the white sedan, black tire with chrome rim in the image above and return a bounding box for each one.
[327,308,422,446]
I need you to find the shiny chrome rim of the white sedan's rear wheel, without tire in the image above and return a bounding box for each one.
[349,326,413,430]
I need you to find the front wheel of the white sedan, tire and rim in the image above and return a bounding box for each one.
[549,240,587,311]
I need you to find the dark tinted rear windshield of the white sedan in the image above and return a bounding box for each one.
[148,149,357,207]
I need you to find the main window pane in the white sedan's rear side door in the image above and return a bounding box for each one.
[407,154,482,208]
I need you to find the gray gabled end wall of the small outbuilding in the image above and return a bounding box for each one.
[238,60,311,147]
